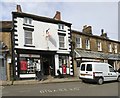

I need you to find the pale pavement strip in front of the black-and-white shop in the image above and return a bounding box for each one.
[0,77,81,86]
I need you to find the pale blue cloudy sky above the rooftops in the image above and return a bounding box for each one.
[0,0,119,40]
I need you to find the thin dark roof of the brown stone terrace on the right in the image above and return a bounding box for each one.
[71,29,120,43]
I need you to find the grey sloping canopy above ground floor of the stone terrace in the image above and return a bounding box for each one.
[75,49,120,60]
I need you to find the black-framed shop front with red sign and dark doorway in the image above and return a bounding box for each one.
[14,49,55,79]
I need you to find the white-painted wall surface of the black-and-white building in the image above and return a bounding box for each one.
[13,11,73,77]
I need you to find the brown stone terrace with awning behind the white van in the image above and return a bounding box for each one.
[72,26,120,75]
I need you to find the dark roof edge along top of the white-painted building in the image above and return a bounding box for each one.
[12,12,72,26]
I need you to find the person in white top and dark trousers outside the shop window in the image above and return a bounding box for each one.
[36,60,42,81]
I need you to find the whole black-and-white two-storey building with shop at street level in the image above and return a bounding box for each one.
[12,5,73,79]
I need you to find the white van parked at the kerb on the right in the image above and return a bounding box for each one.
[79,62,120,84]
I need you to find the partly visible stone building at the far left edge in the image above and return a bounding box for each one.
[0,21,12,81]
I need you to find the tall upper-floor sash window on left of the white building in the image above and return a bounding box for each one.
[25,30,33,45]
